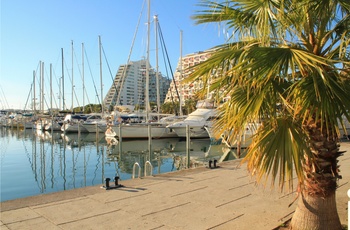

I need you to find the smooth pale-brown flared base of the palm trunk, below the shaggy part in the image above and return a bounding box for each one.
[291,192,341,230]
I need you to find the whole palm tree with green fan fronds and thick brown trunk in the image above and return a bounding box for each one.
[188,0,350,229]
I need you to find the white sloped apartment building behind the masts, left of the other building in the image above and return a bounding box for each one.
[104,60,170,110]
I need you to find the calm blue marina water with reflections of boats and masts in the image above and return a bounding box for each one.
[0,128,243,201]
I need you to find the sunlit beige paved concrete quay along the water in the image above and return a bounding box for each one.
[0,142,350,230]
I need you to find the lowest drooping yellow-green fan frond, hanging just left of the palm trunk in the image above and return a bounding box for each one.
[243,116,312,189]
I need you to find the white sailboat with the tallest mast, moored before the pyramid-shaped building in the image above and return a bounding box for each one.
[105,0,177,139]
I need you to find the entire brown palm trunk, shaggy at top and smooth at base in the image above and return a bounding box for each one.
[291,122,342,230]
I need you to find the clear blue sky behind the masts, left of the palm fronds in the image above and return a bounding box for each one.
[0,0,225,109]
